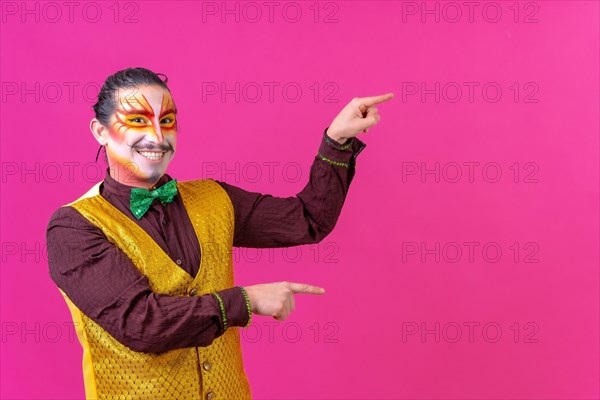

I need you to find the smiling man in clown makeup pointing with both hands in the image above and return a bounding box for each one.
[47,68,393,400]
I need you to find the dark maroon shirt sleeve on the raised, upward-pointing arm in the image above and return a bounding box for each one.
[215,128,366,248]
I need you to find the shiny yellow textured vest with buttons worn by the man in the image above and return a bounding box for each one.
[55,179,251,400]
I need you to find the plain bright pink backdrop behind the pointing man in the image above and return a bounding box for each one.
[0,1,600,399]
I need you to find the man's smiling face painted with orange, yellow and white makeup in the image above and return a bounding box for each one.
[106,85,177,187]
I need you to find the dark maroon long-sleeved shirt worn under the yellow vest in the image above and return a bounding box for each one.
[46,129,366,353]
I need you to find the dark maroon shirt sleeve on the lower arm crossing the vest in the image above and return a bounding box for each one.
[46,207,250,353]
